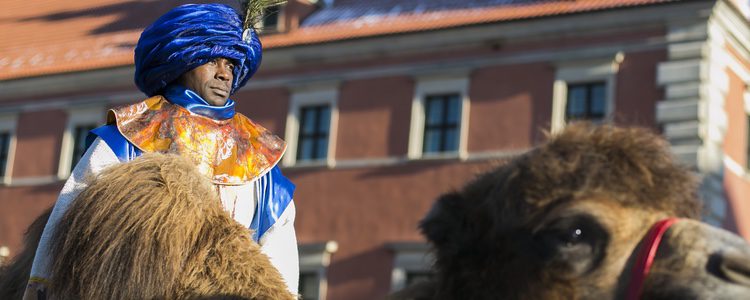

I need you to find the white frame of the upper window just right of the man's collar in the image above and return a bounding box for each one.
[282,84,339,167]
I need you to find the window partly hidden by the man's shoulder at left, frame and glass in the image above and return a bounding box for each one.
[57,107,106,178]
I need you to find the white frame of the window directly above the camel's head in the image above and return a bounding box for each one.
[551,52,625,133]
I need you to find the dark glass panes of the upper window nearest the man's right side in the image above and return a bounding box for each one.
[297,104,331,161]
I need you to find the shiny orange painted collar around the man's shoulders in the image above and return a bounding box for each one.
[107,96,286,185]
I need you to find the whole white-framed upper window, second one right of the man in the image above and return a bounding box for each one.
[408,76,469,159]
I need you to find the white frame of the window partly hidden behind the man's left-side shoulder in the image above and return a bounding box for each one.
[57,106,106,180]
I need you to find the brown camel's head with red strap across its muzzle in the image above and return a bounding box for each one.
[391,124,750,299]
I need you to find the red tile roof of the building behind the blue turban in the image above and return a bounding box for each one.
[0,0,677,80]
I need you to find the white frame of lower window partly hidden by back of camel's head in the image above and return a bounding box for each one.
[388,242,435,292]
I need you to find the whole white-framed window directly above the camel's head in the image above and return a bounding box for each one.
[551,53,624,133]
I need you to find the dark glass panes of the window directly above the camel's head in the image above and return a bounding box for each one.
[565,82,607,121]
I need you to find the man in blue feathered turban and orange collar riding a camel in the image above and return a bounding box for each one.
[24,4,299,299]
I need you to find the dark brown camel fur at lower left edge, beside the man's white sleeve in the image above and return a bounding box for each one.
[0,208,52,299]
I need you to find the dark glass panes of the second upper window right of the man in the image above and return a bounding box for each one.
[422,94,461,153]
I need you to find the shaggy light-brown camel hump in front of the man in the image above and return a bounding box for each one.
[39,154,294,299]
